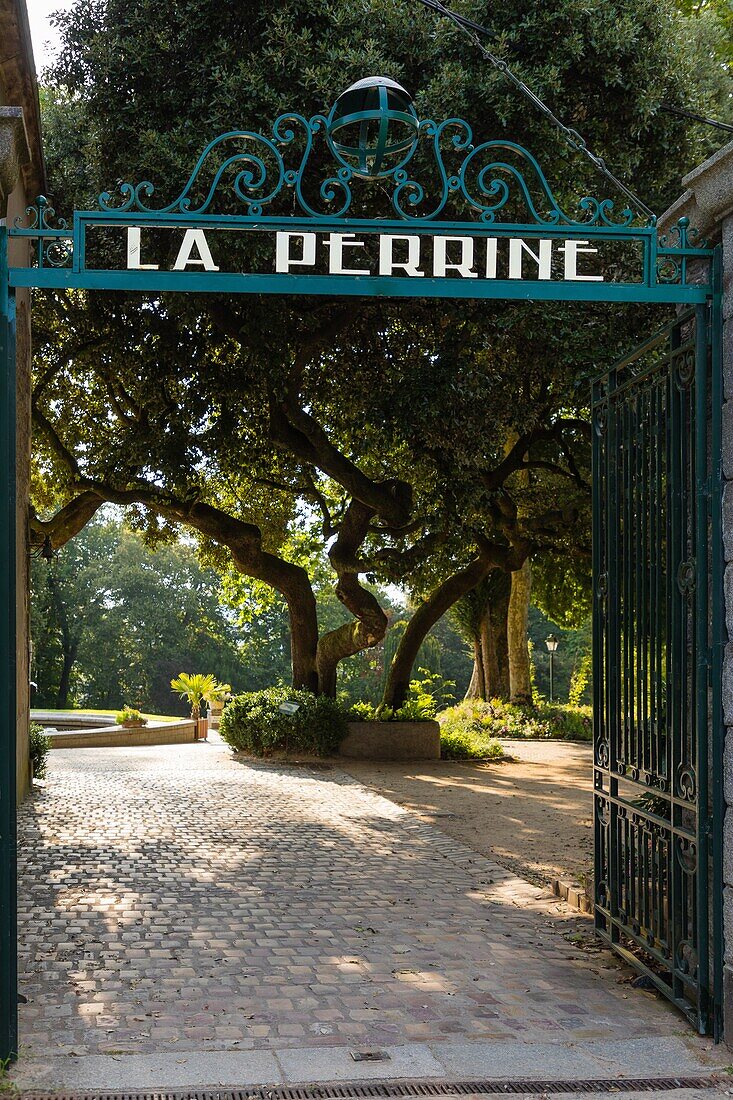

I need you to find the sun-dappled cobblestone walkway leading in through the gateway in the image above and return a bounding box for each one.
[12,745,730,1087]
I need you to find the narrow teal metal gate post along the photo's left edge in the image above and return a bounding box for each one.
[0,226,18,1060]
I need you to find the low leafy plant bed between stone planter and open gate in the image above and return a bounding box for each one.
[438,699,593,741]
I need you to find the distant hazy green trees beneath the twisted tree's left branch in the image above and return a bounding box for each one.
[31,508,245,715]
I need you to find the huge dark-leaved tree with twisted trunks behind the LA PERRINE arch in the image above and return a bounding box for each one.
[33,0,726,705]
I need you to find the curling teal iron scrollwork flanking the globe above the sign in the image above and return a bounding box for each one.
[91,112,647,229]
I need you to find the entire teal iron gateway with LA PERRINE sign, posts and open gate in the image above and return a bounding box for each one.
[0,78,721,1057]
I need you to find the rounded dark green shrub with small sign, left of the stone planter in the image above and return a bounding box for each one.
[219,688,347,756]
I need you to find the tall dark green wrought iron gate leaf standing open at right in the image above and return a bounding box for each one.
[592,294,722,1035]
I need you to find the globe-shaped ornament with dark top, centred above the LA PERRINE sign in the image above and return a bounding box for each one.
[327,76,419,179]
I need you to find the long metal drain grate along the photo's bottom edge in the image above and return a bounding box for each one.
[20,1076,721,1100]
